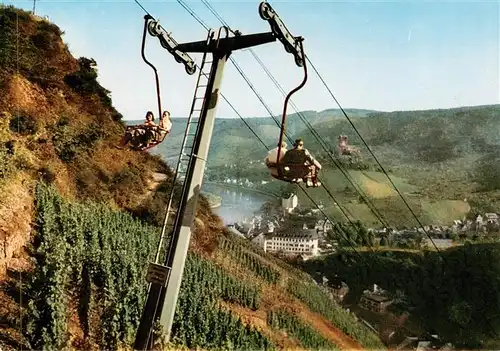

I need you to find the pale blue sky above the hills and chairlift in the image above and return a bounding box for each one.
[0,0,500,120]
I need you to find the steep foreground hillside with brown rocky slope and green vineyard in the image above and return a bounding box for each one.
[0,6,385,350]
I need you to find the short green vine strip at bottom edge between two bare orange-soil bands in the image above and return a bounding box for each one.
[267,309,339,351]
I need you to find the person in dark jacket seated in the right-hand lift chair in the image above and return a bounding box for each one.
[280,139,321,187]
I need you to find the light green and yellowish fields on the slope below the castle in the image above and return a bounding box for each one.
[258,168,470,227]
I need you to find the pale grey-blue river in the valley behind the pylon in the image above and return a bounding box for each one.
[202,184,274,224]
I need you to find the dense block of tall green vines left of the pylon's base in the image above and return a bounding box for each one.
[24,184,159,349]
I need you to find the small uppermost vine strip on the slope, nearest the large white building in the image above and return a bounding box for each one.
[219,238,280,284]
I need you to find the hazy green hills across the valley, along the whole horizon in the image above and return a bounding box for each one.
[141,105,500,226]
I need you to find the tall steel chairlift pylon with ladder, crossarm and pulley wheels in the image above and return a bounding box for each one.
[134,1,305,350]
